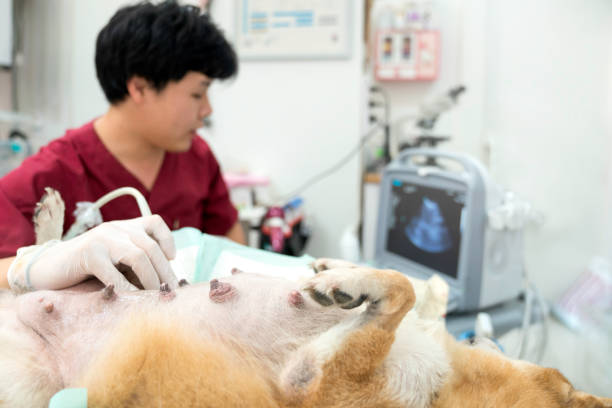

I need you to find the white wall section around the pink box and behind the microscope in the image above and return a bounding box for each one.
[370,0,487,160]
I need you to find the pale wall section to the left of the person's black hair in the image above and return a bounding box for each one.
[16,0,132,146]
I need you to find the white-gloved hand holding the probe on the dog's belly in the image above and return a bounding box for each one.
[8,215,178,292]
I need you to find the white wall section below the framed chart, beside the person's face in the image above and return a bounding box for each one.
[205,1,364,257]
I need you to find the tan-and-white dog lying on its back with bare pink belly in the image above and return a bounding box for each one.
[0,190,612,408]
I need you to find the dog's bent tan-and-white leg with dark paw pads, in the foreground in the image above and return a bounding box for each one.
[281,267,415,407]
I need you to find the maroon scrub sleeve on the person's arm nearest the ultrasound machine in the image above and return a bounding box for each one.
[202,158,238,235]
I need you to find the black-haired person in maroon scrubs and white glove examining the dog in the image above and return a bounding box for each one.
[0,1,244,291]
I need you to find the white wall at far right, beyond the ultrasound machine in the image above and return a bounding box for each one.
[484,0,612,299]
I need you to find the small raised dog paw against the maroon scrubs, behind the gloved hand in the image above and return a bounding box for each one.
[33,187,65,244]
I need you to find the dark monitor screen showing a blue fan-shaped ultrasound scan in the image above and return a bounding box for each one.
[386,180,465,278]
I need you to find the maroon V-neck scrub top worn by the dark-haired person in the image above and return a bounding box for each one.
[0,121,238,258]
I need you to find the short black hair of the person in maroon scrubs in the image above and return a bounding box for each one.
[96,0,238,103]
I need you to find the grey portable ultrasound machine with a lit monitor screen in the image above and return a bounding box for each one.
[376,149,523,311]
